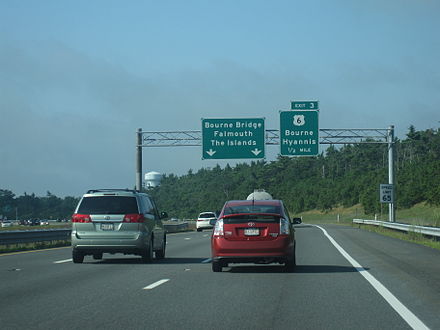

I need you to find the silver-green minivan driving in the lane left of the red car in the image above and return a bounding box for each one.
[72,189,168,263]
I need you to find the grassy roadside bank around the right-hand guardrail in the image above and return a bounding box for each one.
[292,203,440,250]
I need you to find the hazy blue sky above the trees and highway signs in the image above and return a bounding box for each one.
[0,0,440,196]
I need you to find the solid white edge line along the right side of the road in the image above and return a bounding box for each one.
[314,225,429,329]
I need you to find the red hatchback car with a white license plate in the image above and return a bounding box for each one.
[211,200,301,272]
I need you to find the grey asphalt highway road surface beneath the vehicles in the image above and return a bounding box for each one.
[0,224,440,329]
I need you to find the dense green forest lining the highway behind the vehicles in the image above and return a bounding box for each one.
[0,126,440,219]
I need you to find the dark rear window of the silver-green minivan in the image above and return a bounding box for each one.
[77,196,139,214]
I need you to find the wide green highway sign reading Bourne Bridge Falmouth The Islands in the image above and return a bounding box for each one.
[202,118,265,159]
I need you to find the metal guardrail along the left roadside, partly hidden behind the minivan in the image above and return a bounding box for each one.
[0,222,188,245]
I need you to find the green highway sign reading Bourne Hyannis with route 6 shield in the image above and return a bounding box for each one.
[280,110,319,156]
